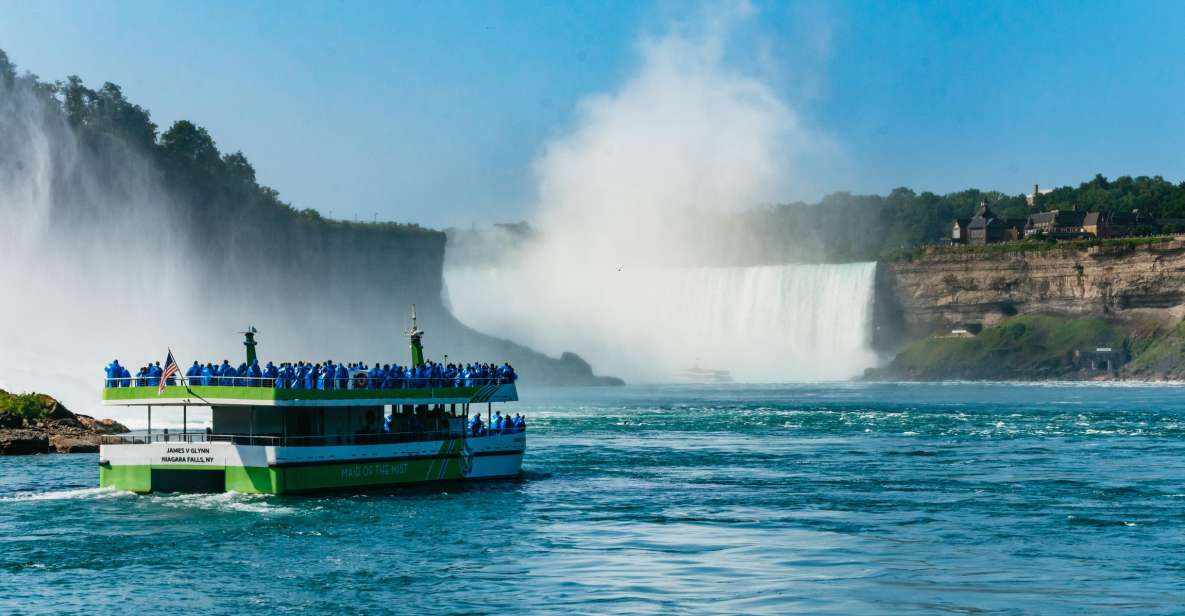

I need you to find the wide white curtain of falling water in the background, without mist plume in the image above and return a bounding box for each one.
[444,263,876,383]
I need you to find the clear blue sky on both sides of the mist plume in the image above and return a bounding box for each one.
[0,0,1185,226]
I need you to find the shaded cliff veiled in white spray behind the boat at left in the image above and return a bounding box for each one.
[0,62,478,426]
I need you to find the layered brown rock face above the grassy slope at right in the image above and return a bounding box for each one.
[878,239,1185,347]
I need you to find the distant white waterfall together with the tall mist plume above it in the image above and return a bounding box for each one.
[446,5,875,380]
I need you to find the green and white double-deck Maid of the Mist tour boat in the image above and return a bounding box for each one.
[98,316,526,494]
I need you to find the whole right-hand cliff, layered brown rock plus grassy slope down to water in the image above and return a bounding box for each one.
[867,238,1185,380]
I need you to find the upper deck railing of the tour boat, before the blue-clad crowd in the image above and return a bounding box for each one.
[103,373,515,391]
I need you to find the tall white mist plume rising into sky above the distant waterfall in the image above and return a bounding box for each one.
[534,5,839,265]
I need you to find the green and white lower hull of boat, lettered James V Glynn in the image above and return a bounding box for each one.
[98,432,526,494]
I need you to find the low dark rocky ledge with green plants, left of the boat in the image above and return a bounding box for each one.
[0,390,128,456]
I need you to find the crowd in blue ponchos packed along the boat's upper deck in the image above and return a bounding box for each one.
[104,359,518,390]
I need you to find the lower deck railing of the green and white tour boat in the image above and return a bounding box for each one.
[98,430,495,447]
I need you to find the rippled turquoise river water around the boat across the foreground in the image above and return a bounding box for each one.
[0,384,1185,615]
